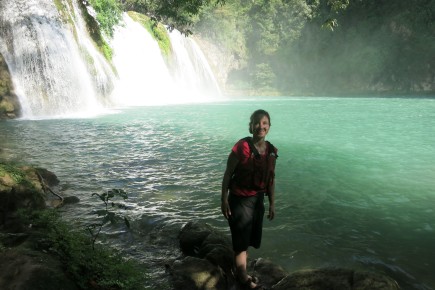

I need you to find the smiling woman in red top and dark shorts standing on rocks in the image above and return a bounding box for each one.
[221,110,278,289]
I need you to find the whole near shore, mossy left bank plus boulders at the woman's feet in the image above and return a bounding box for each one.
[0,163,399,290]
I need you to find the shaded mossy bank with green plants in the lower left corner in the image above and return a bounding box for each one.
[0,163,147,290]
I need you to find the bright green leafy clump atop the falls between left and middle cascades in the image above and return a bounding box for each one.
[89,0,122,37]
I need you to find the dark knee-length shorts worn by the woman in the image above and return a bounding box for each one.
[228,193,264,253]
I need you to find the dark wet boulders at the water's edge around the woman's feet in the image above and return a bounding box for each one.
[169,221,400,290]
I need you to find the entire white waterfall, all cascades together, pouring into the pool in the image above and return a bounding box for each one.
[0,0,220,119]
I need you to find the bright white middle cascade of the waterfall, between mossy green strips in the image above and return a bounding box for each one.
[111,14,175,106]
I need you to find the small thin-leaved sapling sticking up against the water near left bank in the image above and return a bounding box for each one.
[87,189,130,248]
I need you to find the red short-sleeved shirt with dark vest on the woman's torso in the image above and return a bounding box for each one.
[230,139,269,196]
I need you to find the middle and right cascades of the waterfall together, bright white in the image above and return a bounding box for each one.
[112,13,220,105]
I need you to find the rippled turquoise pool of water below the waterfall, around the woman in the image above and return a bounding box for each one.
[0,98,435,289]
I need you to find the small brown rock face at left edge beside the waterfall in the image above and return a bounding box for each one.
[0,54,21,119]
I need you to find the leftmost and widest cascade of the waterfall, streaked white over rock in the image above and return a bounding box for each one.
[0,0,114,118]
